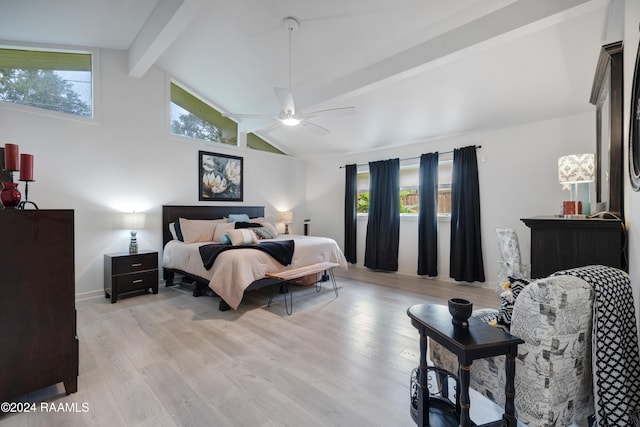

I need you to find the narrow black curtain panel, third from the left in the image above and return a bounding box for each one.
[418,153,439,277]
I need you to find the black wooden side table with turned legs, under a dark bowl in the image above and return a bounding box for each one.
[407,304,524,427]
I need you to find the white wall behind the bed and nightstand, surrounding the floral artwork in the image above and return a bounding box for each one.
[0,50,305,297]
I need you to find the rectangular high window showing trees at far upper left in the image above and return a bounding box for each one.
[0,48,93,117]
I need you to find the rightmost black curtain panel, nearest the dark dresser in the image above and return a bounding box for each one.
[449,146,485,282]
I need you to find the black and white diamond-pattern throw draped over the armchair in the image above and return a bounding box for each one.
[554,265,640,427]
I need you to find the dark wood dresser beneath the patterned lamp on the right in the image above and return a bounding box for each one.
[522,216,627,278]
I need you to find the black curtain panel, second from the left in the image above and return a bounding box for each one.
[364,159,400,271]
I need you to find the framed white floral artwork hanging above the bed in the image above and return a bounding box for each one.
[198,151,243,202]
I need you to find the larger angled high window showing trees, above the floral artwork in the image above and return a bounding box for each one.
[170,82,238,145]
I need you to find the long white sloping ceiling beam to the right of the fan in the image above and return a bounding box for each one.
[296,0,604,106]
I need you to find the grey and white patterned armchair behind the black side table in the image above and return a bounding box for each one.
[429,276,594,427]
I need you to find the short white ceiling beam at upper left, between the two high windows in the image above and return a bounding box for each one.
[129,0,203,78]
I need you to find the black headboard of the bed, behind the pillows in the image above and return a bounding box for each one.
[162,205,264,247]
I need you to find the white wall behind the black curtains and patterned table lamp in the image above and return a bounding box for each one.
[307,112,596,287]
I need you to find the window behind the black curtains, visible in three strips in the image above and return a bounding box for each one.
[357,160,453,216]
